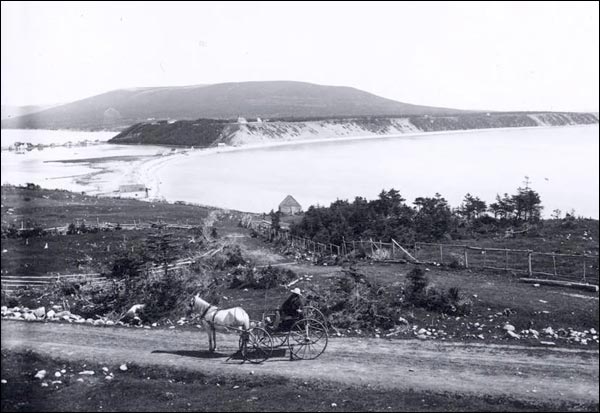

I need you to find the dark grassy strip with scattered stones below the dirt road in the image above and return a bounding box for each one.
[1,351,598,412]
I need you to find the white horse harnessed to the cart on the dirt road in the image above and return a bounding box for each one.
[190,294,250,353]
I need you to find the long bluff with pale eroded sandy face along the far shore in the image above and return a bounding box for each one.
[109,113,598,147]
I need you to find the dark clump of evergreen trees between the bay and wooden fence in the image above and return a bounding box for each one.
[288,180,543,245]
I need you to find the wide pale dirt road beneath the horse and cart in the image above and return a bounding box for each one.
[2,321,599,403]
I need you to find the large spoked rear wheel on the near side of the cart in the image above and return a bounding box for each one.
[288,318,328,360]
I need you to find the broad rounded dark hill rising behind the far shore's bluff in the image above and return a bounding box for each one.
[2,81,463,130]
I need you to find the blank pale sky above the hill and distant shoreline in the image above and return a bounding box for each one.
[1,1,600,112]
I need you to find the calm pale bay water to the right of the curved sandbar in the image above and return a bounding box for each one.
[158,125,599,218]
